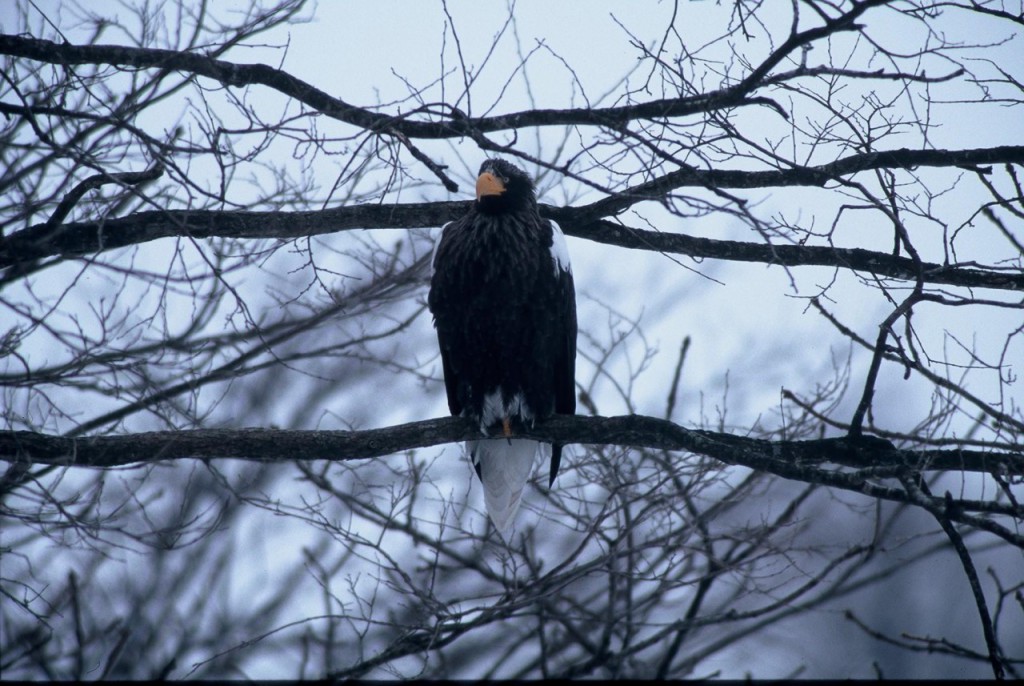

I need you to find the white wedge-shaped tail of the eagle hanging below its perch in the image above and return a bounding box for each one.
[466,438,551,541]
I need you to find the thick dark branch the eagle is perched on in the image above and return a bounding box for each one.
[0,415,1024,477]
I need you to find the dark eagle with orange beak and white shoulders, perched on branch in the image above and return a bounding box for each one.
[427,159,577,539]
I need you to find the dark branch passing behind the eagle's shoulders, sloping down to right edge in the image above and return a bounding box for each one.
[0,202,1024,291]
